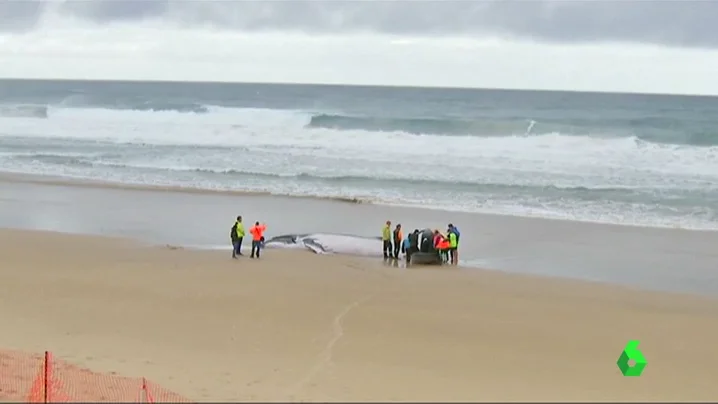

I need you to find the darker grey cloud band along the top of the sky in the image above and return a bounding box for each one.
[0,0,718,48]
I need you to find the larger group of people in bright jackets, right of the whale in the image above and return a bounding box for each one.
[382,220,461,265]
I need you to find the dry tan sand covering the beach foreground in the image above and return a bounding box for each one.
[0,226,718,401]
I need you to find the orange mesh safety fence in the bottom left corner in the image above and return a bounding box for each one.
[0,350,192,403]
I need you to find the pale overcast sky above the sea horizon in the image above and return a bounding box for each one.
[0,0,718,93]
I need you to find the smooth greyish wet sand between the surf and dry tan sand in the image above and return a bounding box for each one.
[0,174,718,295]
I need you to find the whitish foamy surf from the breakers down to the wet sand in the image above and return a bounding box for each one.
[0,104,718,229]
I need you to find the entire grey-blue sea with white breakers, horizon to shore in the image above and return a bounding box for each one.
[0,80,718,230]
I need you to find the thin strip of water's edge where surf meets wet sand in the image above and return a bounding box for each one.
[0,170,718,234]
